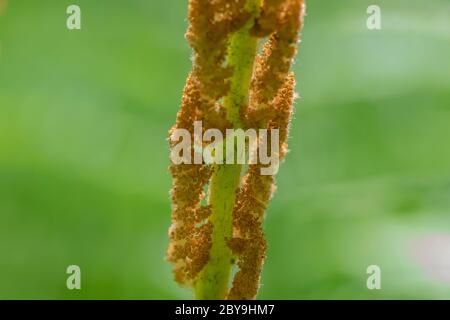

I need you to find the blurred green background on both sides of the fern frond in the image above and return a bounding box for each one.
[0,0,450,299]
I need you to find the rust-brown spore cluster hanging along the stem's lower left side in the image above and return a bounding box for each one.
[168,75,212,284]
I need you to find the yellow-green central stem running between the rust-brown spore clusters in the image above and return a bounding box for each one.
[195,0,261,300]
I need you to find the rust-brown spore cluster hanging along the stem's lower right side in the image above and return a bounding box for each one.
[228,75,295,300]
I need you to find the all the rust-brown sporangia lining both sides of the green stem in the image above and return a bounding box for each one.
[169,0,304,299]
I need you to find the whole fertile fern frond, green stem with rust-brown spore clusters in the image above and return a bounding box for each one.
[168,0,304,299]
